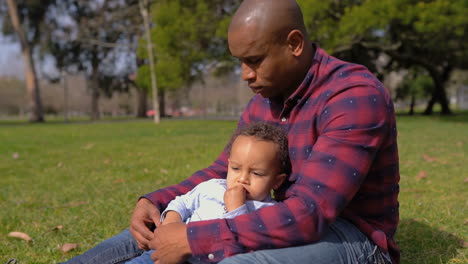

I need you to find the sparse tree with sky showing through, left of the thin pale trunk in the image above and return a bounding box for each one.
[48,0,142,120]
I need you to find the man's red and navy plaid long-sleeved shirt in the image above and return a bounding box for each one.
[145,46,399,263]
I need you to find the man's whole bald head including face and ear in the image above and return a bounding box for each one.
[228,0,314,101]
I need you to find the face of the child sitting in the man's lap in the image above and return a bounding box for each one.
[227,135,286,201]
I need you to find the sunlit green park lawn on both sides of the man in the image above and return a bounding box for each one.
[0,114,468,264]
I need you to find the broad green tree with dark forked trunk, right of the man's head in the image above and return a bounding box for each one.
[298,0,468,114]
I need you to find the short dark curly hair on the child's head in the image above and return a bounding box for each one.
[227,122,291,175]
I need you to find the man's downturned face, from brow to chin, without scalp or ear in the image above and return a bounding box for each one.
[228,26,295,99]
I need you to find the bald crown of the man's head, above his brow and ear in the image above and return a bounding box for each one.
[229,0,307,40]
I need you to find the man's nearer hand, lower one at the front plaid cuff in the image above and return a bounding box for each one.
[150,223,192,264]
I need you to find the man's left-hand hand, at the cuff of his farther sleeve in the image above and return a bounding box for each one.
[130,198,161,250]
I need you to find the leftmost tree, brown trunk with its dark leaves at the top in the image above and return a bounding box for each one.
[3,0,52,122]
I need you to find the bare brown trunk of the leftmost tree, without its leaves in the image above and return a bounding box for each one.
[7,0,44,122]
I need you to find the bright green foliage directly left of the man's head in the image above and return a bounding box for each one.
[137,0,238,93]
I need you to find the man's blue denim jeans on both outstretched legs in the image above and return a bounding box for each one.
[62,218,391,264]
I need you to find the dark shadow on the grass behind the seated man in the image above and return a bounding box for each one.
[396,219,462,264]
